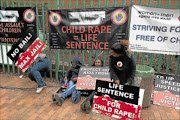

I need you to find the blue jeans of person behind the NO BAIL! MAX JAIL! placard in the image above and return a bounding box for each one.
[28,58,50,87]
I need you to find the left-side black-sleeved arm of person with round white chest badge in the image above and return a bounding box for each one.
[109,57,120,84]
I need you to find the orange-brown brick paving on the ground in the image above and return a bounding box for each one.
[0,73,180,120]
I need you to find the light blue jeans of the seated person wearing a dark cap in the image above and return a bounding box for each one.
[61,80,76,102]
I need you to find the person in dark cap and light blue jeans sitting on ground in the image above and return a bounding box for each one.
[52,57,84,106]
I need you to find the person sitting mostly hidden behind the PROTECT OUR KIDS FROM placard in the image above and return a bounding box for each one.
[81,59,103,114]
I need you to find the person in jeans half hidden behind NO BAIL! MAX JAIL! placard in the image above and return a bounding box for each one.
[28,53,50,93]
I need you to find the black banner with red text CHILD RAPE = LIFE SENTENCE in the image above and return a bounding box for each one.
[49,7,129,50]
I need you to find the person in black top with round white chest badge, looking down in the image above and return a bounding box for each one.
[109,42,136,85]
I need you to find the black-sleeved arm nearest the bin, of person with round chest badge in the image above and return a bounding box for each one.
[125,56,136,85]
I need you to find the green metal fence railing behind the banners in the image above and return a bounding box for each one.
[0,0,180,79]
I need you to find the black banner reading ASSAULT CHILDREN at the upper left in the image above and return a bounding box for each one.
[0,7,36,43]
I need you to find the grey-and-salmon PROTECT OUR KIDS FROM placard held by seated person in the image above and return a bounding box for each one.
[76,66,111,90]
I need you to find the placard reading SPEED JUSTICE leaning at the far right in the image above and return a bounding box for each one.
[153,73,180,109]
